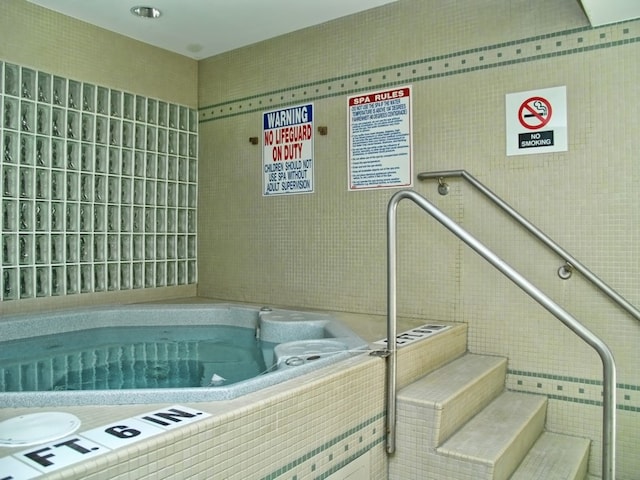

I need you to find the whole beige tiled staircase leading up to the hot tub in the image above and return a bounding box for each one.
[389,327,590,480]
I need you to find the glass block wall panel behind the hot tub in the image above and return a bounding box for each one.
[0,61,198,301]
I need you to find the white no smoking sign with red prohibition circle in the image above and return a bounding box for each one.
[506,87,568,155]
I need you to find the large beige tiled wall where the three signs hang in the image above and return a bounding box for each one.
[198,0,640,478]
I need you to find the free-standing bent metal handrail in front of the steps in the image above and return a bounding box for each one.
[386,190,616,480]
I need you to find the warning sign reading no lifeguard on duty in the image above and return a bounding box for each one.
[262,103,313,197]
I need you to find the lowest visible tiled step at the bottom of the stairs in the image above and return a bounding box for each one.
[510,432,590,480]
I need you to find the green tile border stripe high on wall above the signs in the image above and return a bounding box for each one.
[198,20,640,123]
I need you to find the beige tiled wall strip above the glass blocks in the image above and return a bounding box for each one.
[0,0,198,107]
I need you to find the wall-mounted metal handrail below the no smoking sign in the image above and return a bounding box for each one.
[418,170,640,320]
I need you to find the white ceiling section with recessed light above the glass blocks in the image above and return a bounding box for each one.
[28,0,396,60]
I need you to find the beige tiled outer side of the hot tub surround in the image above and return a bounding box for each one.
[26,356,386,480]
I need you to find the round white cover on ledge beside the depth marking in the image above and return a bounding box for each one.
[0,412,81,447]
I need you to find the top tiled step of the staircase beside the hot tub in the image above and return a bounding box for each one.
[397,354,507,447]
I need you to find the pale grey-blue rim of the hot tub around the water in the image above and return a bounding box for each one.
[0,303,367,408]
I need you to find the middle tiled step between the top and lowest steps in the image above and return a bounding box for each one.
[437,392,547,480]
